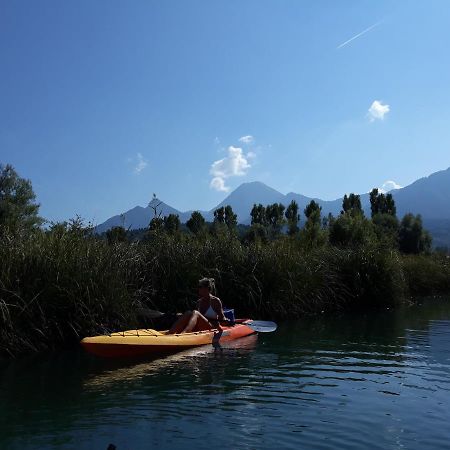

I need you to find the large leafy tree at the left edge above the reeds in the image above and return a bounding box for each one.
[0,164,44,231]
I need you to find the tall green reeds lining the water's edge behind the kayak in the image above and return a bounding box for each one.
[0,230,450,355]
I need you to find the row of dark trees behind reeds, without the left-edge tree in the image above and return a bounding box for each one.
[106,188,432,254]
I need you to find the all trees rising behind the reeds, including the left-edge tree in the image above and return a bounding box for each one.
[0,164,431,254]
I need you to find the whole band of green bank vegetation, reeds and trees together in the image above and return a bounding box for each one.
[0,166,450,355]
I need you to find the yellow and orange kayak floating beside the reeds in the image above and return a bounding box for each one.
[81,320,255,358]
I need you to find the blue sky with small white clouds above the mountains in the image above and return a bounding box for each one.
[0,0,450,223]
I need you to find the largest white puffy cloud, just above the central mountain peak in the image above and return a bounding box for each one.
[209,146,254,192]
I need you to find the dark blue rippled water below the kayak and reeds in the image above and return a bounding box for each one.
[0,300,450,450]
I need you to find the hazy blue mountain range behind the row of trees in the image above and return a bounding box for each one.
[96,168,450,246]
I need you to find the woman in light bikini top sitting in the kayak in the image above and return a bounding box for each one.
[167,278,229,334]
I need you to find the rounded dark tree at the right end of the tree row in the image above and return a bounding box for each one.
[398,214,431,254]
